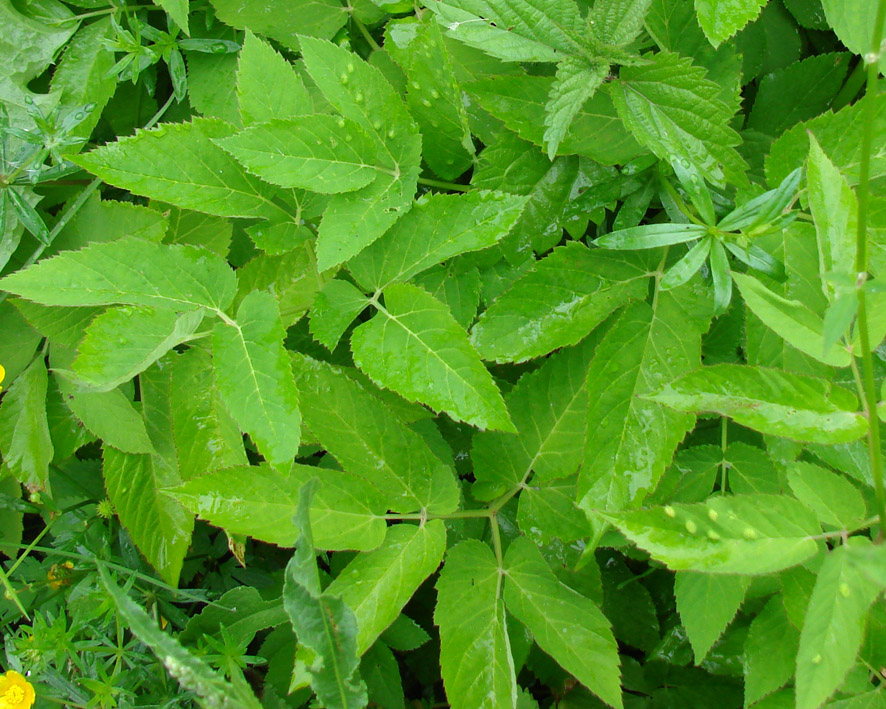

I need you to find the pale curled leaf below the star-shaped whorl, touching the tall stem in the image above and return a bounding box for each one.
[733,273,850,367]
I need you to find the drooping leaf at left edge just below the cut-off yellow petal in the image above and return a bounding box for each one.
[0,357,53,489]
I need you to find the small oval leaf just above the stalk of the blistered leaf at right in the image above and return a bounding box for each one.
[788,461,867,530]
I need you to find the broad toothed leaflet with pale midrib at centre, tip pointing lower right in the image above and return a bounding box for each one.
[351,283,514,431]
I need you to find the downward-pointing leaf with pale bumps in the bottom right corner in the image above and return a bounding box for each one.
[796,537,882,709]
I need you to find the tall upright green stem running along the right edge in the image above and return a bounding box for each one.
[855,0,886,541]
